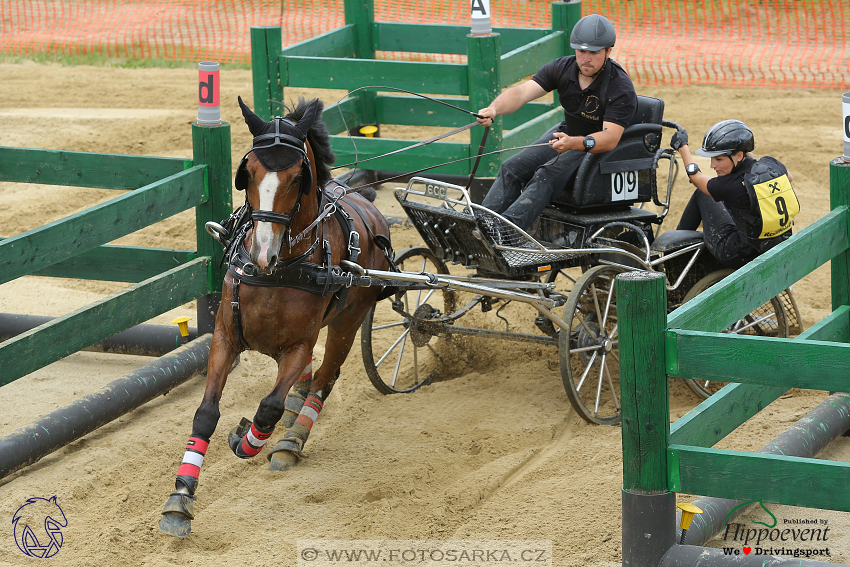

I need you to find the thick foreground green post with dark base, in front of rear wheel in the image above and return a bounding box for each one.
[616,271,676,567]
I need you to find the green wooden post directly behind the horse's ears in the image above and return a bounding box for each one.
[251,26,287,120]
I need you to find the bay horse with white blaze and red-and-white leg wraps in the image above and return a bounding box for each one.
[159,97,392,537]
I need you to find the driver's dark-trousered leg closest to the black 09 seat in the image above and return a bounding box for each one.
[502,150,587,233]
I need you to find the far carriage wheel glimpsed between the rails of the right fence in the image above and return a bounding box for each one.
[682,269,788,399]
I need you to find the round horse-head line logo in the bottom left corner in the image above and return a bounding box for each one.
[12,496,68,559]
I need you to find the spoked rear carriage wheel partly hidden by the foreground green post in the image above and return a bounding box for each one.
[558,265,625,425]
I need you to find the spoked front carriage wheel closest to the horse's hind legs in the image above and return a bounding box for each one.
[360,247,454,394]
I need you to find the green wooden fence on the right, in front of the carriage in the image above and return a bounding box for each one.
[617,158,850,559]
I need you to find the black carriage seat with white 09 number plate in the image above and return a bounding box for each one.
[551,95,664,212]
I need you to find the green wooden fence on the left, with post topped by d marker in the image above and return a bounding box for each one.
[0,124,233,386]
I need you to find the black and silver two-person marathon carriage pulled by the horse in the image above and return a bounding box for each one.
[343,96,802,424]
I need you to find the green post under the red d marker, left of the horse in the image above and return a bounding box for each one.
[192,122,233,335]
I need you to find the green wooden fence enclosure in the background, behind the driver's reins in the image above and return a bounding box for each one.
[245,0,581,177]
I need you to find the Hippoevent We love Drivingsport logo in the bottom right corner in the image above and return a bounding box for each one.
[723,500,831,557]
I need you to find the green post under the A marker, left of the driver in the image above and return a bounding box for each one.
[466,33,500,177]
